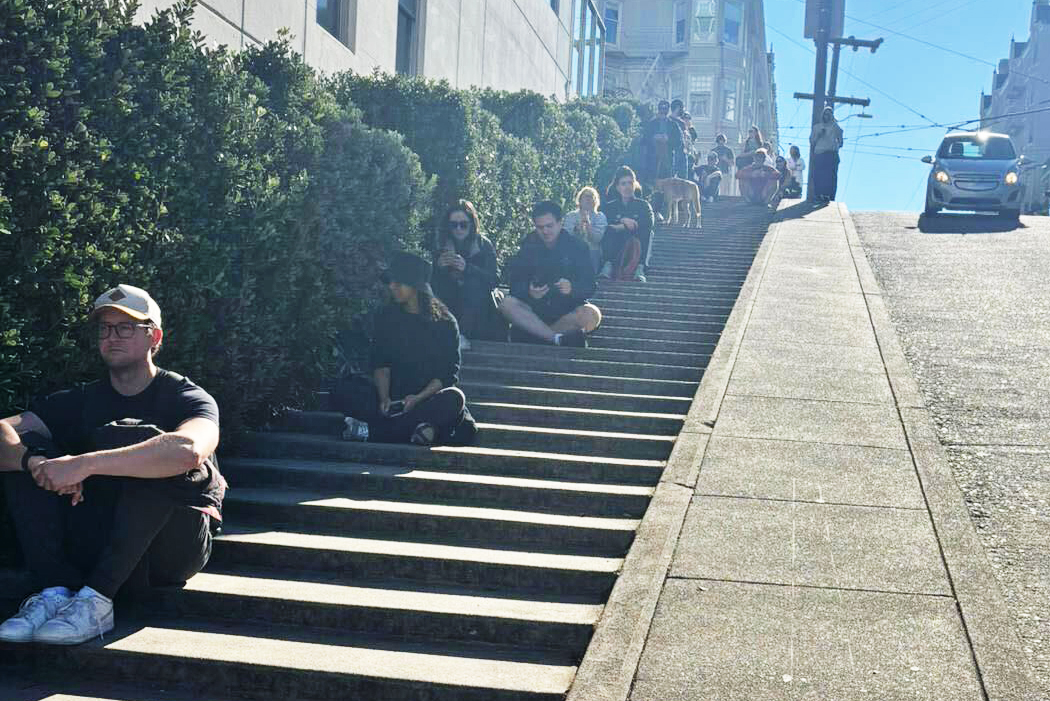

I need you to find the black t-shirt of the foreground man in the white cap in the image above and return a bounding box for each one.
[29,369,218,455]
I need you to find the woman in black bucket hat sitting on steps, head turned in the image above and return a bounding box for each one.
[340,252,466,446]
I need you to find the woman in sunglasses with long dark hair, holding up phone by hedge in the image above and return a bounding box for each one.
[433,199,500,351]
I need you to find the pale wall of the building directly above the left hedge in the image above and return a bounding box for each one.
[139,0,605,100]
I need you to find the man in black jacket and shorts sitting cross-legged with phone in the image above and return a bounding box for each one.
[500,201,602,346]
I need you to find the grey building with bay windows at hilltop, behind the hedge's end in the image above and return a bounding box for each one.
[602,0,780,150]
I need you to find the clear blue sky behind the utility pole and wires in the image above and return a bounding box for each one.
[764,0,1032,211]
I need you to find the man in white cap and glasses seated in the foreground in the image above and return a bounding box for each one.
[0,284,226,644]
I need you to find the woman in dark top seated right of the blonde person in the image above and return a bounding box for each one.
[600,166,653,282]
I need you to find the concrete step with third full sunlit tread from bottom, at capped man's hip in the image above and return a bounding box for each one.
[209,525,623,603]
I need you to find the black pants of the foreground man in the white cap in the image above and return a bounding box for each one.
[3,472,211,598]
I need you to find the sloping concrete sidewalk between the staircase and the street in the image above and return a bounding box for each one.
[569,199,1035,701]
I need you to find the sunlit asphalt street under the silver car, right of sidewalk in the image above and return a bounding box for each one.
[854,212,1050,694]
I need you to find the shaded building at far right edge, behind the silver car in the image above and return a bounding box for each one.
[981,0,1050,213]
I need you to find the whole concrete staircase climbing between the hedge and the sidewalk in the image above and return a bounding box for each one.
[0,201,769,701]
